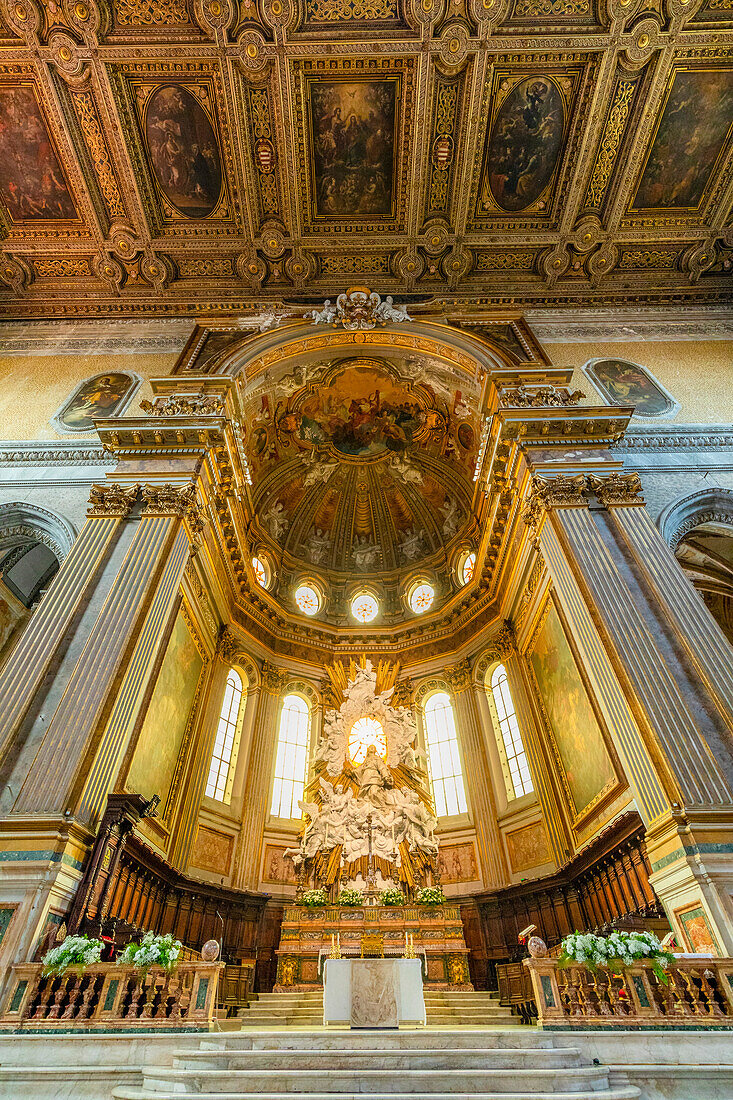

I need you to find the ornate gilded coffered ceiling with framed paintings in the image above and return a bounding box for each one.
[0,0,733,316]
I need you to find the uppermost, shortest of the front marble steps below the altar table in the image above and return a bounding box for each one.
[198,1016,545,1053]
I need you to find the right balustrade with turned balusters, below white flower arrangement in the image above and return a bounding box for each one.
[524,958,733,1029]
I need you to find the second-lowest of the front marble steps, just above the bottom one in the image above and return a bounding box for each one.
[138,1054,609,1097]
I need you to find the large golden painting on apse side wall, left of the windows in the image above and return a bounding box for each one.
[125,612,204,807]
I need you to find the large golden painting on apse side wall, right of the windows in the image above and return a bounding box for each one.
[529,602,615,814]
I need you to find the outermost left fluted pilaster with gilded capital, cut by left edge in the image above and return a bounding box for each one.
[0,482,138,774]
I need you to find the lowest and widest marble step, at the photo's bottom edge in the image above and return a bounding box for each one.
[112,1085,642,1100]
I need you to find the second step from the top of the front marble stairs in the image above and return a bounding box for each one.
[173,1046,580,1073]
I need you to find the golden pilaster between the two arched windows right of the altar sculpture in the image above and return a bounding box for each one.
[445,661,508,887]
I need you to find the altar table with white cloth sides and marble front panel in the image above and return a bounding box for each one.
[324,958,425,1027]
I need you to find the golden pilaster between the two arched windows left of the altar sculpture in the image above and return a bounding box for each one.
[232,662,287,890]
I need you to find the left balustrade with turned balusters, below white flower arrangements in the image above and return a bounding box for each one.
[0,961,223,1031]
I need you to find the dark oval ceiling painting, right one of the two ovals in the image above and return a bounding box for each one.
[489,76,565,210]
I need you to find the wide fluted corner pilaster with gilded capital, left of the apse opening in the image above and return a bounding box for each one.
[12,485,200,814]
